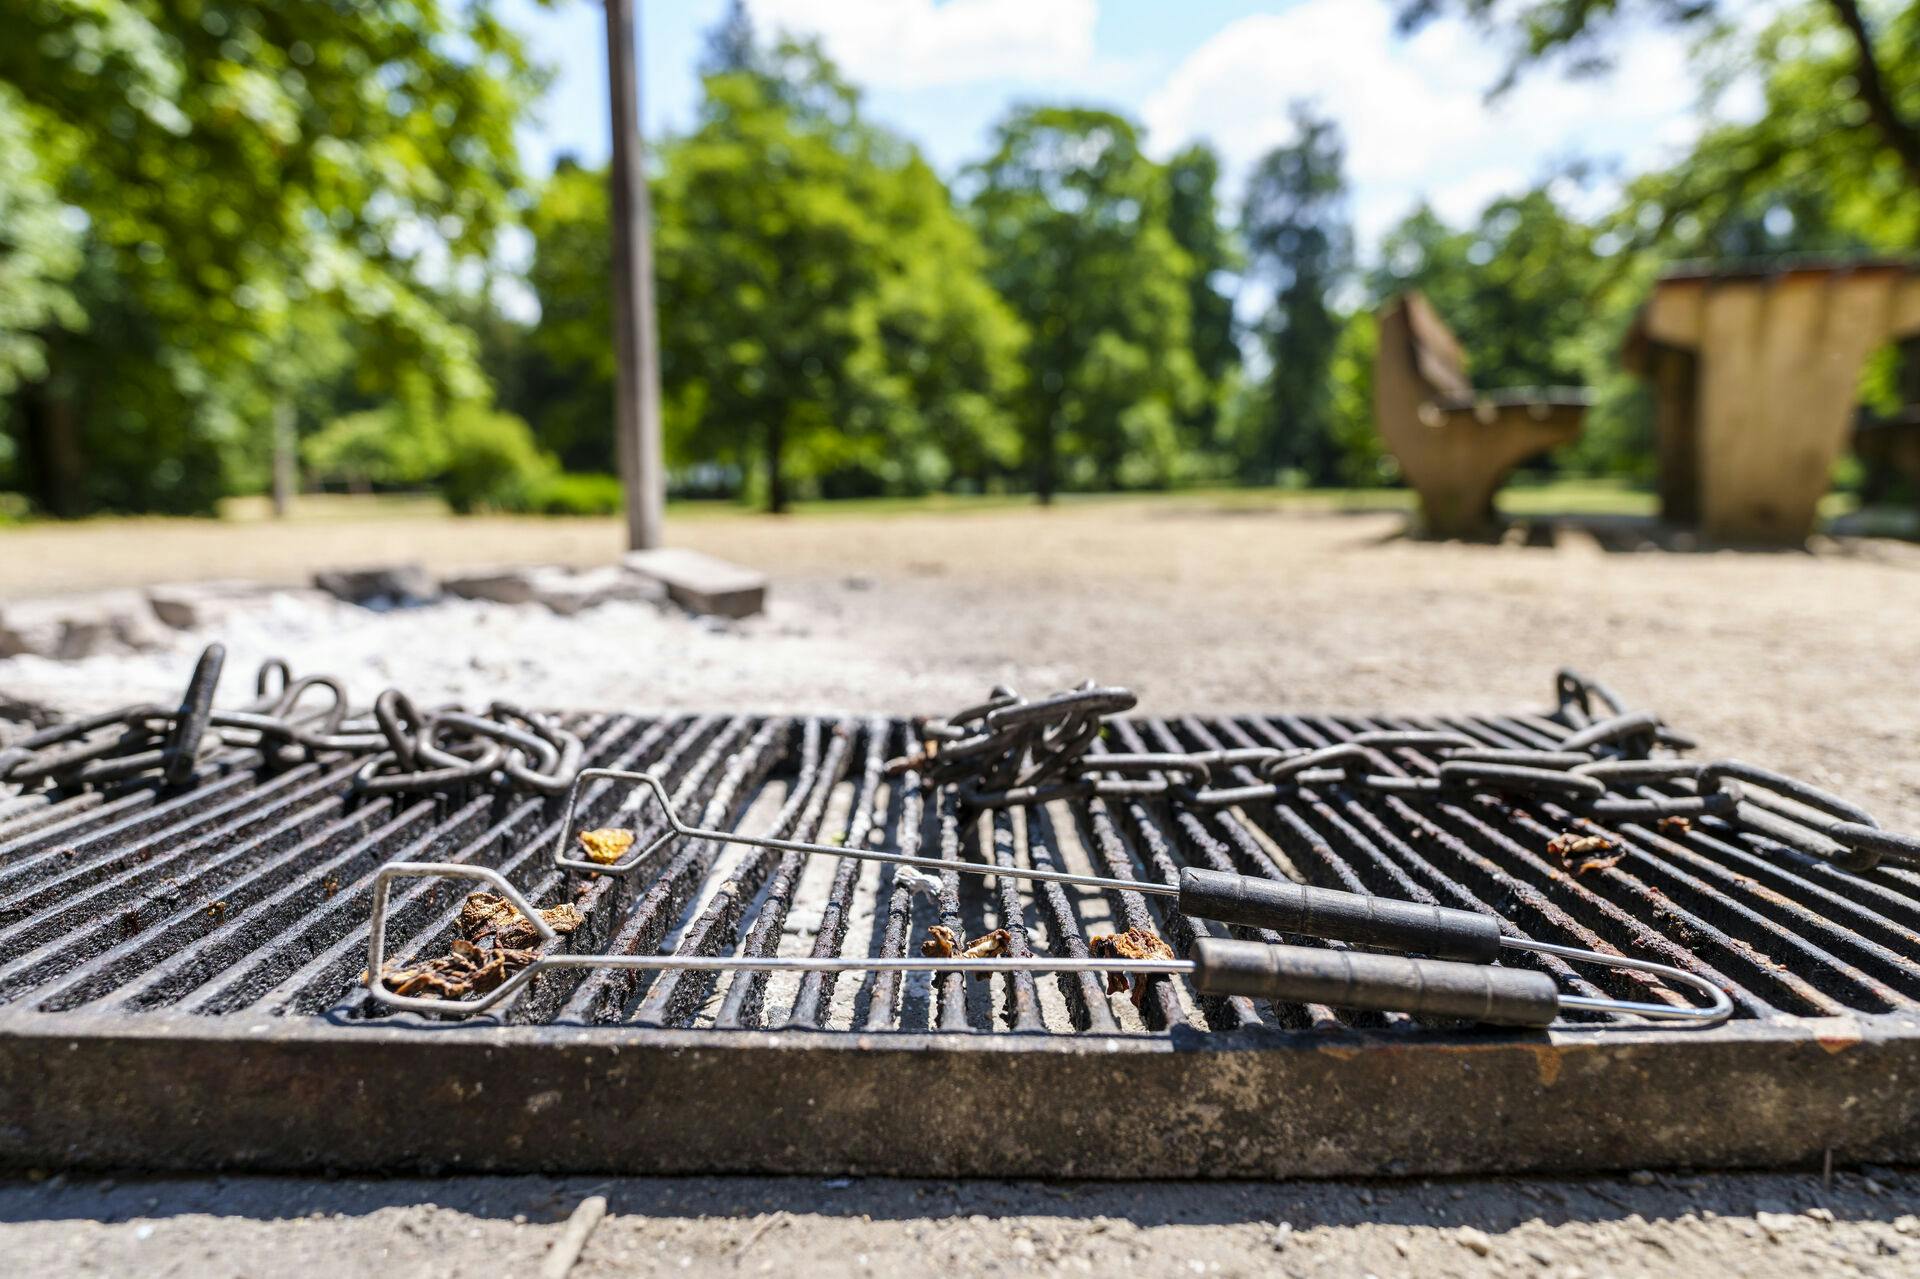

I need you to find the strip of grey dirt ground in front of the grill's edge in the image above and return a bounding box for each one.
[0,1170,1920,1279]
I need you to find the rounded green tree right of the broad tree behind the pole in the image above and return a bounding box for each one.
[968,108,1204,501]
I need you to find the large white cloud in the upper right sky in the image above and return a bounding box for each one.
[1144,0,1697,244]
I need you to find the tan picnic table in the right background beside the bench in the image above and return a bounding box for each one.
[1624,261,1920,545]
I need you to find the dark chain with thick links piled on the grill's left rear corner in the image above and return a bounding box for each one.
[0,643,584,795]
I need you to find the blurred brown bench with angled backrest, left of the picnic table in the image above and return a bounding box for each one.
[1373,292,1590,538]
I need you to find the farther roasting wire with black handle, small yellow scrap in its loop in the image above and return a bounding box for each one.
[553,768,1726,1016]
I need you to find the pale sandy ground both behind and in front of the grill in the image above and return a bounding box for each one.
[0,501,1920,1277]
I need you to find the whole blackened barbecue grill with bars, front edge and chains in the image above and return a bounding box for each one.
[0,653,1920,1175]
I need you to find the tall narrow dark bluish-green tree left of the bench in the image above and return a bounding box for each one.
[1236,106,1354,484]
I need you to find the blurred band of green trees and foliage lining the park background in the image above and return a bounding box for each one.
[0,0,1920,513]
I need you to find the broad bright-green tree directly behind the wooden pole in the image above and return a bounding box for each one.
[528,29,1023,511]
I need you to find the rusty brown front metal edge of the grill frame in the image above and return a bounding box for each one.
[0,1012,1920,1177]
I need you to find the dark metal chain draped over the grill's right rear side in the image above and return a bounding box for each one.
[887,670,1920,870]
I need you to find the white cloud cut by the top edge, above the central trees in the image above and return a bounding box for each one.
[751,0,1098,88]
